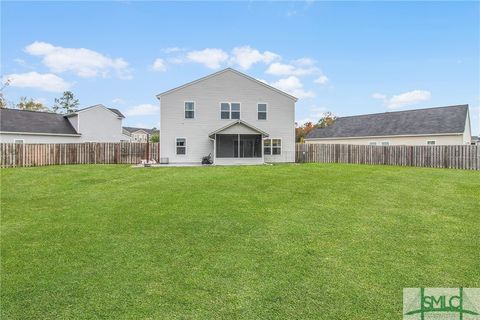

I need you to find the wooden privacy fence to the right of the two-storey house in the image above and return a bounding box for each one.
[295,143,480,170]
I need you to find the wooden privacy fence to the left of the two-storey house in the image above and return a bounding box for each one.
[0,142,160,168]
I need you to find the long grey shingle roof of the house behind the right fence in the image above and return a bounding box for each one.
[306,105,468,139]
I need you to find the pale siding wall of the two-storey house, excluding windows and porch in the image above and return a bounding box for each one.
[160,71,295,163]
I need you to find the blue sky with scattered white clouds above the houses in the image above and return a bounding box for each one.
[1,1,480,134]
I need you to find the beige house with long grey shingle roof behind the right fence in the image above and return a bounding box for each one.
[305,105,472,145]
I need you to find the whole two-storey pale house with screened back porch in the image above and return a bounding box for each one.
[157,68,297,164]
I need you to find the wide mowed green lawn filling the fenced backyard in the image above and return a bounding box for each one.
[0,164,480,319]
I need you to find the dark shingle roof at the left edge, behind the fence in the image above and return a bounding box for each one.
[0,109,79,135]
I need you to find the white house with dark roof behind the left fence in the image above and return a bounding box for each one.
[0,104,130,143]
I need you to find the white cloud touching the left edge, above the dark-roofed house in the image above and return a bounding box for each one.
[3,72,72,92]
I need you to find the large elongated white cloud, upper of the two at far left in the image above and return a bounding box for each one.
[25,41,131,79]
